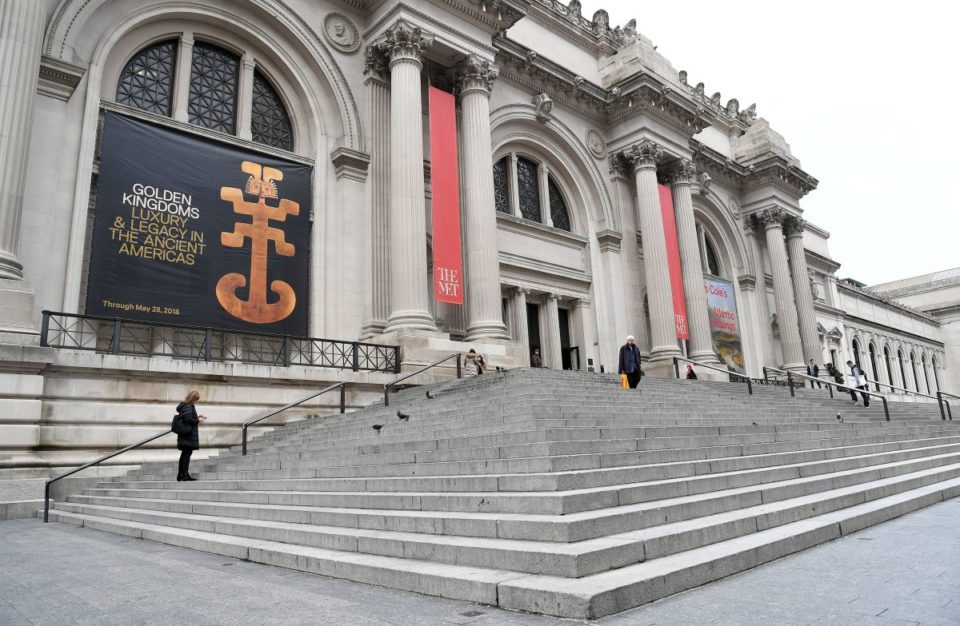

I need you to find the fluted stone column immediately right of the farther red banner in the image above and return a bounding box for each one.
[670,160,720,364]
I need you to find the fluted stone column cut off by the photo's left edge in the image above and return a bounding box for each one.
[0,0,46,280]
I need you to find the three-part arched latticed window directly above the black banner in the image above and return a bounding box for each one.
[116,39,294,150]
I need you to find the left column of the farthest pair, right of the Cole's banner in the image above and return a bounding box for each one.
[757,208,806,372]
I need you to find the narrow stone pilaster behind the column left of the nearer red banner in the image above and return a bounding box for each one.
[360,46,390,338]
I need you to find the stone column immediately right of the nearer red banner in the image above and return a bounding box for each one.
[460,54,509,341]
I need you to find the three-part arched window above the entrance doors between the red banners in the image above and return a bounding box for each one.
[493,156,573,232]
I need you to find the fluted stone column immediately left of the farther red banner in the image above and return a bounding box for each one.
[623,140,684,361]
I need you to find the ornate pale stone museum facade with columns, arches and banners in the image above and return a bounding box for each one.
[0,0,948,466]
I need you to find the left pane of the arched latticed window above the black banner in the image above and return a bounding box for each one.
[117,39,177,115]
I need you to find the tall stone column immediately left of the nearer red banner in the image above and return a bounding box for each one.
[376,21,436,332]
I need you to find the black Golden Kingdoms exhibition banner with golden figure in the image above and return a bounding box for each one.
[86,111,312,336]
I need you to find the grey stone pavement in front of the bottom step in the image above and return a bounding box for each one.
[0,499,960,626]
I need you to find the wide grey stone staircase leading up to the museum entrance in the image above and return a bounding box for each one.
[50,370,960,619]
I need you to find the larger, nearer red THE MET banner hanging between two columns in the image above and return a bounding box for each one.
[429,86,463,304]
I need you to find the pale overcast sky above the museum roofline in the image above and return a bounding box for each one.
[583,0,960,284]
